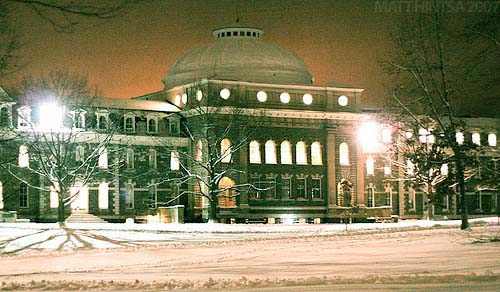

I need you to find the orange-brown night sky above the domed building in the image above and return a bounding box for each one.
[2,0,496,113]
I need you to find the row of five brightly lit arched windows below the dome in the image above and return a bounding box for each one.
[249,140,323,165]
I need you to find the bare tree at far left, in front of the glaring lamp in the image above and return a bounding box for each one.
[2,72,113,222]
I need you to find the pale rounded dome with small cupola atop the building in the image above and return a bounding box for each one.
[163,23,312,90]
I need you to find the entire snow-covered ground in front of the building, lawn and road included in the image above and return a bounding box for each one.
[0,217,500,292]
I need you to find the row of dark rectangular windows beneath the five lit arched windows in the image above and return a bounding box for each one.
[249,175,322,200]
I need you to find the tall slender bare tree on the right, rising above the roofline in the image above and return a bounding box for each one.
[385,6,494,229]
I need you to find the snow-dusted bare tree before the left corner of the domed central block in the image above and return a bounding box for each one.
[158,86,265,222]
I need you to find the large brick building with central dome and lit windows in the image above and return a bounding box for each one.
[0,23,500,223]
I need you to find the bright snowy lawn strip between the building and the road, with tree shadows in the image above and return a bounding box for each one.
[0,217,498,255]
